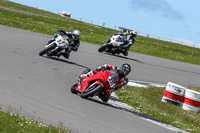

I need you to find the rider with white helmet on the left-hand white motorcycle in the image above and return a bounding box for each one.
[49,29,81,59]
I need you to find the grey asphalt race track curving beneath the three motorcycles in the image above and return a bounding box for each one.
[0,25,200,133]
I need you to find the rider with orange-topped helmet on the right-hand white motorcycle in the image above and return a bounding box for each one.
[107,30,137,56]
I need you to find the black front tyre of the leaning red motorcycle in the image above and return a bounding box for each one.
[80,84,103,98]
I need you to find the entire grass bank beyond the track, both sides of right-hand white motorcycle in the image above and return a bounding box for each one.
[0,0,200,65]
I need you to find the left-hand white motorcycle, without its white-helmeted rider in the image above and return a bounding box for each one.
[39,33,70,56]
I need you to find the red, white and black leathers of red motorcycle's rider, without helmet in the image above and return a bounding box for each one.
[79,64,128,102]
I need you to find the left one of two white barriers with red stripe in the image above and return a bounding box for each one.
[162,82,185,106]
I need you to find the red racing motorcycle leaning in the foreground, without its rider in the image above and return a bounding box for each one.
[71,70,119,99]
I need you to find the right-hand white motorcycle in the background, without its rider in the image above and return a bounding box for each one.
[98,35,125,55]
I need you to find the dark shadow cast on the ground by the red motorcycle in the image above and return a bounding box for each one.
[85,96,162,123]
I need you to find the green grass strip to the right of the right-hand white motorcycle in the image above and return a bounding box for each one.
[131,36,200,65]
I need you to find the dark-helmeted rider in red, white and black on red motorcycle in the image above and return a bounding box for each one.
[79,63,131,102]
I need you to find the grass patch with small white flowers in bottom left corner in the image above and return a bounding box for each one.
[0,111,72,133]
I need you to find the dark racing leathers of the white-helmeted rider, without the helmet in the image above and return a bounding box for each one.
[50,30,80,59]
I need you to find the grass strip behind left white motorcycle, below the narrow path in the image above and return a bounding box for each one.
[0,9,116,44]
